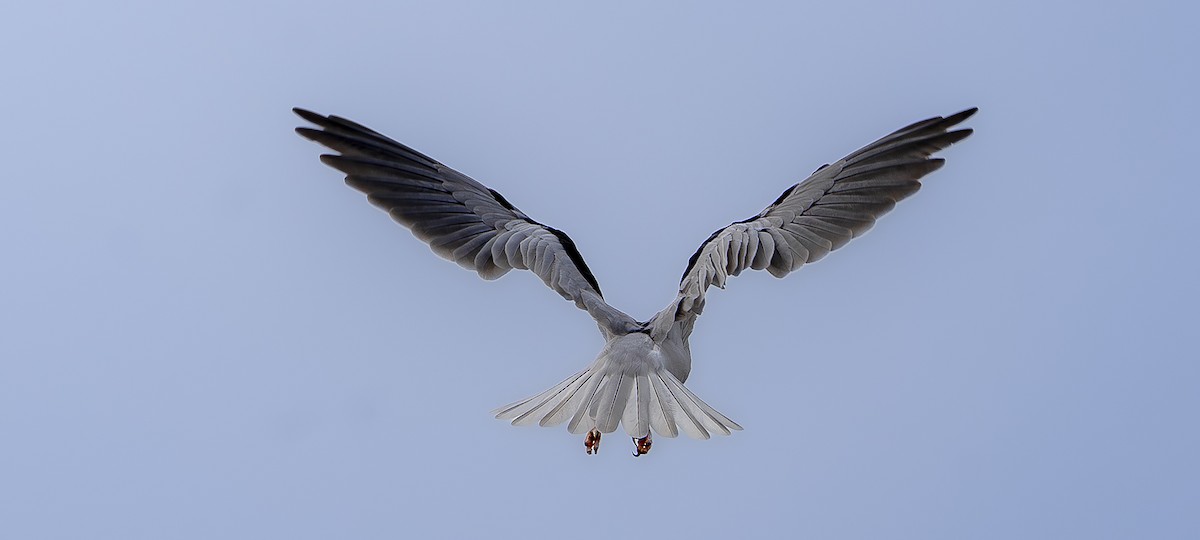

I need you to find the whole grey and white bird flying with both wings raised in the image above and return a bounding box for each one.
[293,108,978,457]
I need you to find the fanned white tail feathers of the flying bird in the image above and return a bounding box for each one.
[492,356,742,439]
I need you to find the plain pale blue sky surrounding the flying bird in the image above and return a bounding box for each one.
[0,1,1200,540]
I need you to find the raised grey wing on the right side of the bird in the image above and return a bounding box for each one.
[650,108,978,340]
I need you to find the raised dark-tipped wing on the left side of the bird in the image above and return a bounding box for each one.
[293,109,636,332]
